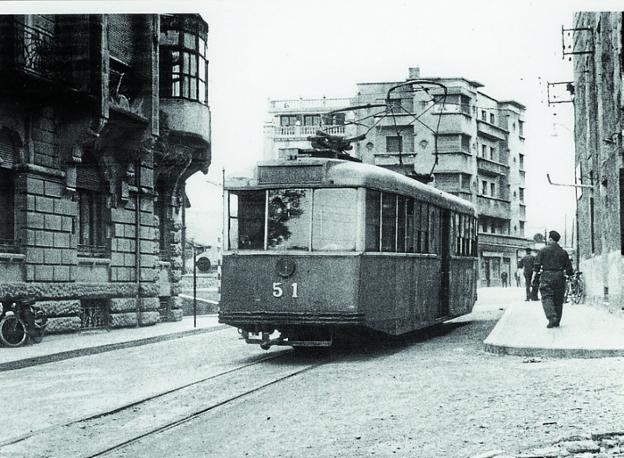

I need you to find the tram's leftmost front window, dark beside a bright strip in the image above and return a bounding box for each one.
[229,191,265,250]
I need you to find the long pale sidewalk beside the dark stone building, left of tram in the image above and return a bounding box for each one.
[0,314,226,372]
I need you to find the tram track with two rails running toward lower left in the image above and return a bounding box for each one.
[0,351,329,457]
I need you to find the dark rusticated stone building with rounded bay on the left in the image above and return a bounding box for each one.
[0,14,210,332]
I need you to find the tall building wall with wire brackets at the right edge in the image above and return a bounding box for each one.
[566,12,624,311]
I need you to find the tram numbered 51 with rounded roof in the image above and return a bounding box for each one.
[219,157,477,349]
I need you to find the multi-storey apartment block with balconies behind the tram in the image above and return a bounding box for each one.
[265,68,533,286]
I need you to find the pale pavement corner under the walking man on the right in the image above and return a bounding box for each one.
[480,288,624,358]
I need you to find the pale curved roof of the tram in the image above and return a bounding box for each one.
[225,158,477,216]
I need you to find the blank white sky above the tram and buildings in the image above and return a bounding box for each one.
[2,0,624,244]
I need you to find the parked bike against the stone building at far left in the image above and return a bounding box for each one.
[0,300,48,347]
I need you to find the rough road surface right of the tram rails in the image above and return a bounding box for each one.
[107,305,624,458]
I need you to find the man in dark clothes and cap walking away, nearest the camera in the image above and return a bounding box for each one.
[533,231,574,328]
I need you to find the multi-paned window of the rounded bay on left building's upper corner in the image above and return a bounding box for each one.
[160,14,208,104]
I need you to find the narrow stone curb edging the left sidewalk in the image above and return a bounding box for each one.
[0,324,229,372]
